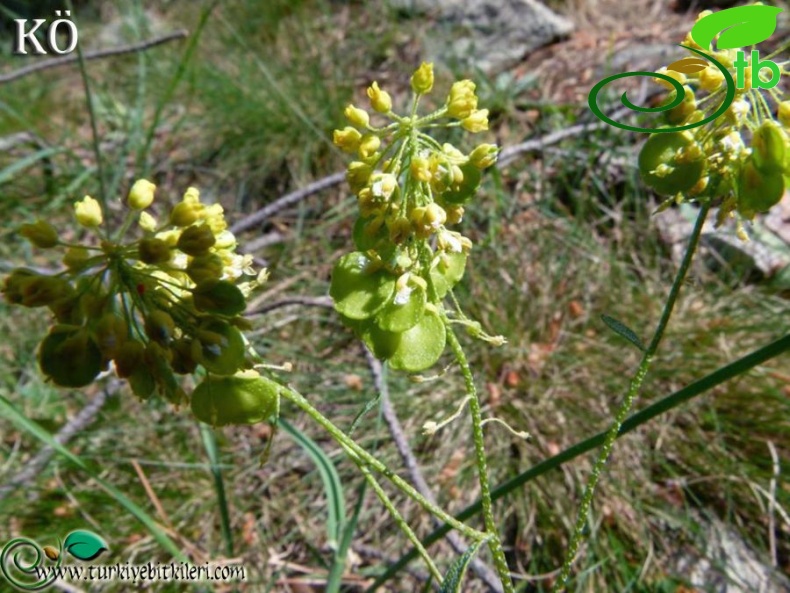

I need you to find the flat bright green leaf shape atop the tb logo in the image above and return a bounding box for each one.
[691,5,782,51]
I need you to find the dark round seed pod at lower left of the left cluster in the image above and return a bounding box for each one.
[38,326,102,387]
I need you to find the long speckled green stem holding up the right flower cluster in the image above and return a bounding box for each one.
[551,203,710,593]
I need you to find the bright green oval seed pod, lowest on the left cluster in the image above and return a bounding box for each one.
[192,371,282,426]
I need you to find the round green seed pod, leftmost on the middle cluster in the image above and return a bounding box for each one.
[329,251,395,319]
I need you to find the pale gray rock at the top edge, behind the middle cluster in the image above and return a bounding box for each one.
[390,0,573,73]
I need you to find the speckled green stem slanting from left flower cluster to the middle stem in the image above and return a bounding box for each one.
[280,387,487,540]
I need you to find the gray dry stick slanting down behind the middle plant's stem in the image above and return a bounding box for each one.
[365,348,502,593]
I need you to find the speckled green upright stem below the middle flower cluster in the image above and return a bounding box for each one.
[444,324,514,593]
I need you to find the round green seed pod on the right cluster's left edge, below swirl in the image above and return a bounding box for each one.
[639,132,705,196]
